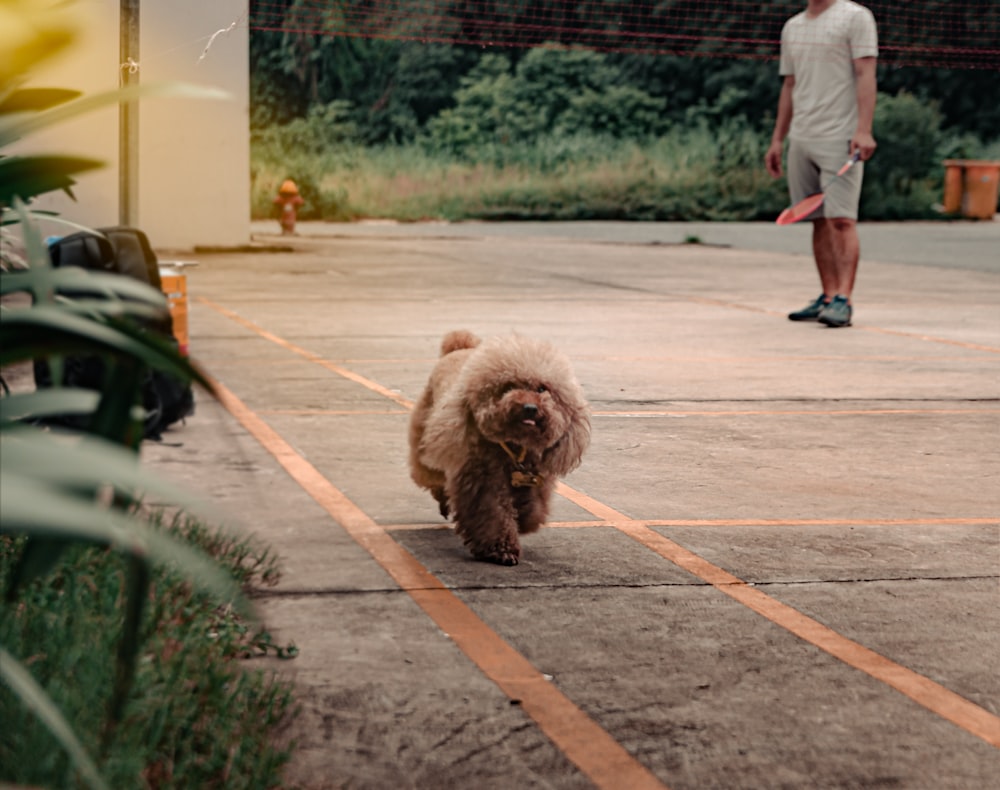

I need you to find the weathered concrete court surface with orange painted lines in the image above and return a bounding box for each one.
[144,223,1000,790]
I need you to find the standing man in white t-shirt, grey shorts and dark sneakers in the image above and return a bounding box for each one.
[764,0,878,327]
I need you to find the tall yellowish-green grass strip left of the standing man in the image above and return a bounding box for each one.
[252,124,787,221]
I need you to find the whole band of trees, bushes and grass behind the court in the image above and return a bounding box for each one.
[251,0,1000,220]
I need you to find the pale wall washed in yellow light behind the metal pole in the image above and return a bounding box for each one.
[18,0,250,249]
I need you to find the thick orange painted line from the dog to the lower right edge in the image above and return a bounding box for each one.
[557,483,1000,748]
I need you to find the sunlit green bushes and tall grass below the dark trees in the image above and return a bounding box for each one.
[252,42,1000,221]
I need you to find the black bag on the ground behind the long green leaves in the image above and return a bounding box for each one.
[34,226,194,440]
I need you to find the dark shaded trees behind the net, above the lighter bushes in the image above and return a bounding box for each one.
[251,0,1000,143]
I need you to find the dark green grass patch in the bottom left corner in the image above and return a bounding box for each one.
[0,513,295,788]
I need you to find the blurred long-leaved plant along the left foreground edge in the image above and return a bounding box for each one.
[0,10,252,788]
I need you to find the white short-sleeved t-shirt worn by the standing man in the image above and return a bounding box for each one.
[779,0,878,141]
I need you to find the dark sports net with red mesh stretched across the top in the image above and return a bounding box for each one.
[250,0,1000,71]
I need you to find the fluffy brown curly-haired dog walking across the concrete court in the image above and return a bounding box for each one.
[410,331,590,565]
